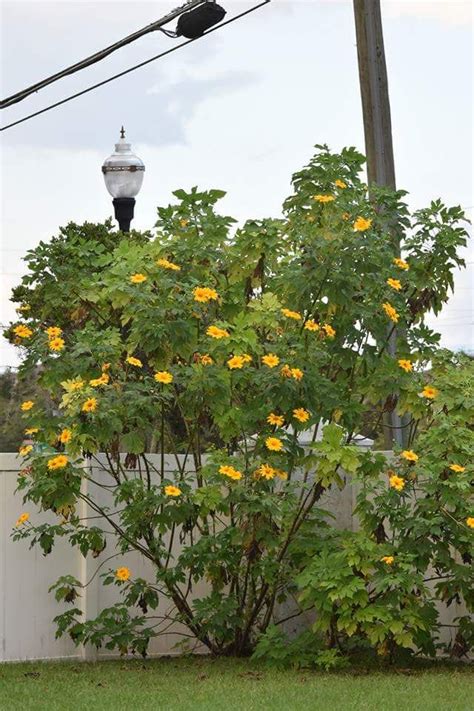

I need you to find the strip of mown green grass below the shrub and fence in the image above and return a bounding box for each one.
[0,657,474,711]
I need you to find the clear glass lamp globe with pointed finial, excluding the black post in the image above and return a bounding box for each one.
[102,126,145,198]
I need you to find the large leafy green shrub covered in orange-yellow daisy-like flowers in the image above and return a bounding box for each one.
[7,147,474,665]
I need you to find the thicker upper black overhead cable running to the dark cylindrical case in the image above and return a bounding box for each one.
[0,0,204,109]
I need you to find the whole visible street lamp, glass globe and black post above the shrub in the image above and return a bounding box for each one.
[102,126,145,232]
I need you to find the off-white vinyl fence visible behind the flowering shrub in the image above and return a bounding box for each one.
[0,440,466,662]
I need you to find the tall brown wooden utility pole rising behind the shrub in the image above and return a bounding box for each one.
[354,0,405,448]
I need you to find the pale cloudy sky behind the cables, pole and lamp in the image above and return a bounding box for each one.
[0,0,474,367]
